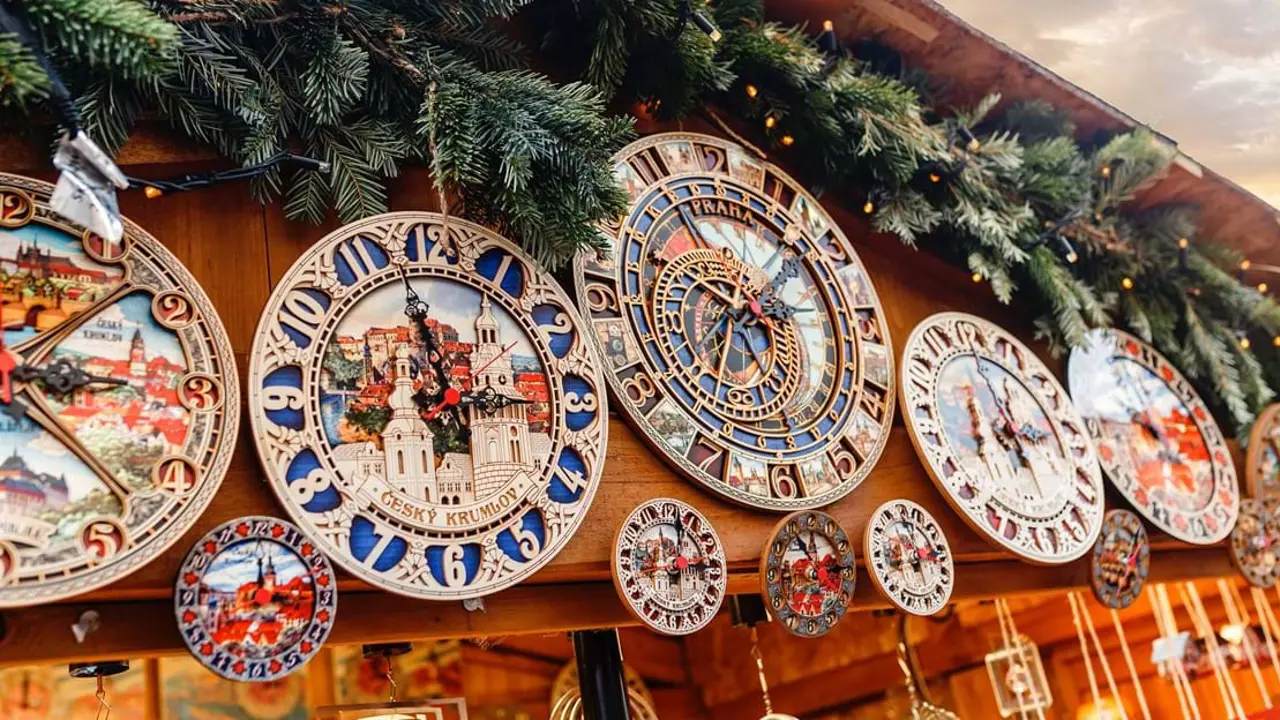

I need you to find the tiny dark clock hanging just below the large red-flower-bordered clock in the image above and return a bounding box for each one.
[1089,510,1151,610]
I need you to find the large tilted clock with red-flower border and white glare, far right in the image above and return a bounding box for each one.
[1068,325,1240,544]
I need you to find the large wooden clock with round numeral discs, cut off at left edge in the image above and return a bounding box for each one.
[0,174,239,607]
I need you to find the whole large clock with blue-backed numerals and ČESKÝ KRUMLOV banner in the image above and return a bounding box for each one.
[250,213,605,600]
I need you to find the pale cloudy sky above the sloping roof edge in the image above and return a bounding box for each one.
[941,0,1280,206]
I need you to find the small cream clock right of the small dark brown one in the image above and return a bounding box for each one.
[863,500,955,615]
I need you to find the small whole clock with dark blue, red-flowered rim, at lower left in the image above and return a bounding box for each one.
[174,516,338,683]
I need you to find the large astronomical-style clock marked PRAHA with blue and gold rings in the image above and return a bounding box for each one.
[575,133,893,510]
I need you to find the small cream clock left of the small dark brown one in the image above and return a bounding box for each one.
[613,497,727,635]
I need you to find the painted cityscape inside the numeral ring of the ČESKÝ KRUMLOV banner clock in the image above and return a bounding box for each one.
[320,278,552,505]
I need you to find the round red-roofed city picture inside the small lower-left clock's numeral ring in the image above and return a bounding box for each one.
[197,539,315,660]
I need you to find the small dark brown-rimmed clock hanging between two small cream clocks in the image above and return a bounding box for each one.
[760,510,854,638]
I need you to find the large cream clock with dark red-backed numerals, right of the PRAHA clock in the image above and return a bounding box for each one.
[901,313,1103,564]
